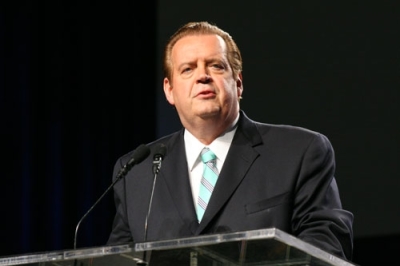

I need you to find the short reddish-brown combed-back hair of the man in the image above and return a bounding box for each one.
[163,21,242,81]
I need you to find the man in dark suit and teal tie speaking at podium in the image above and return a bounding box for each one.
[108,22,353,260]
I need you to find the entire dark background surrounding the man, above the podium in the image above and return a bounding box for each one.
[0,0,400,265]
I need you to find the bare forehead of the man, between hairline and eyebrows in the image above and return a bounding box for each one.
[172,34,226,59]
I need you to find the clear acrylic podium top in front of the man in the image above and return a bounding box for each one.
[0,228,354,266]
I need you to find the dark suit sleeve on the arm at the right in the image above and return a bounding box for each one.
[292,134,353,260]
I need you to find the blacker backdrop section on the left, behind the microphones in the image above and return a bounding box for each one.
[0,1,156,255]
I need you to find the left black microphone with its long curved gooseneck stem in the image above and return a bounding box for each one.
[74,144,150,249]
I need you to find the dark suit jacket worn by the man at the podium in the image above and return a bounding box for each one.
[108,111,353,260]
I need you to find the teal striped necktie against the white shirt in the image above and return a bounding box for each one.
[196,147,218,222]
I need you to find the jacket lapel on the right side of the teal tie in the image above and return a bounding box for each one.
[196,113,262,234]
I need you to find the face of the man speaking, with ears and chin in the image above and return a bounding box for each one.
[164,35,242,126]
